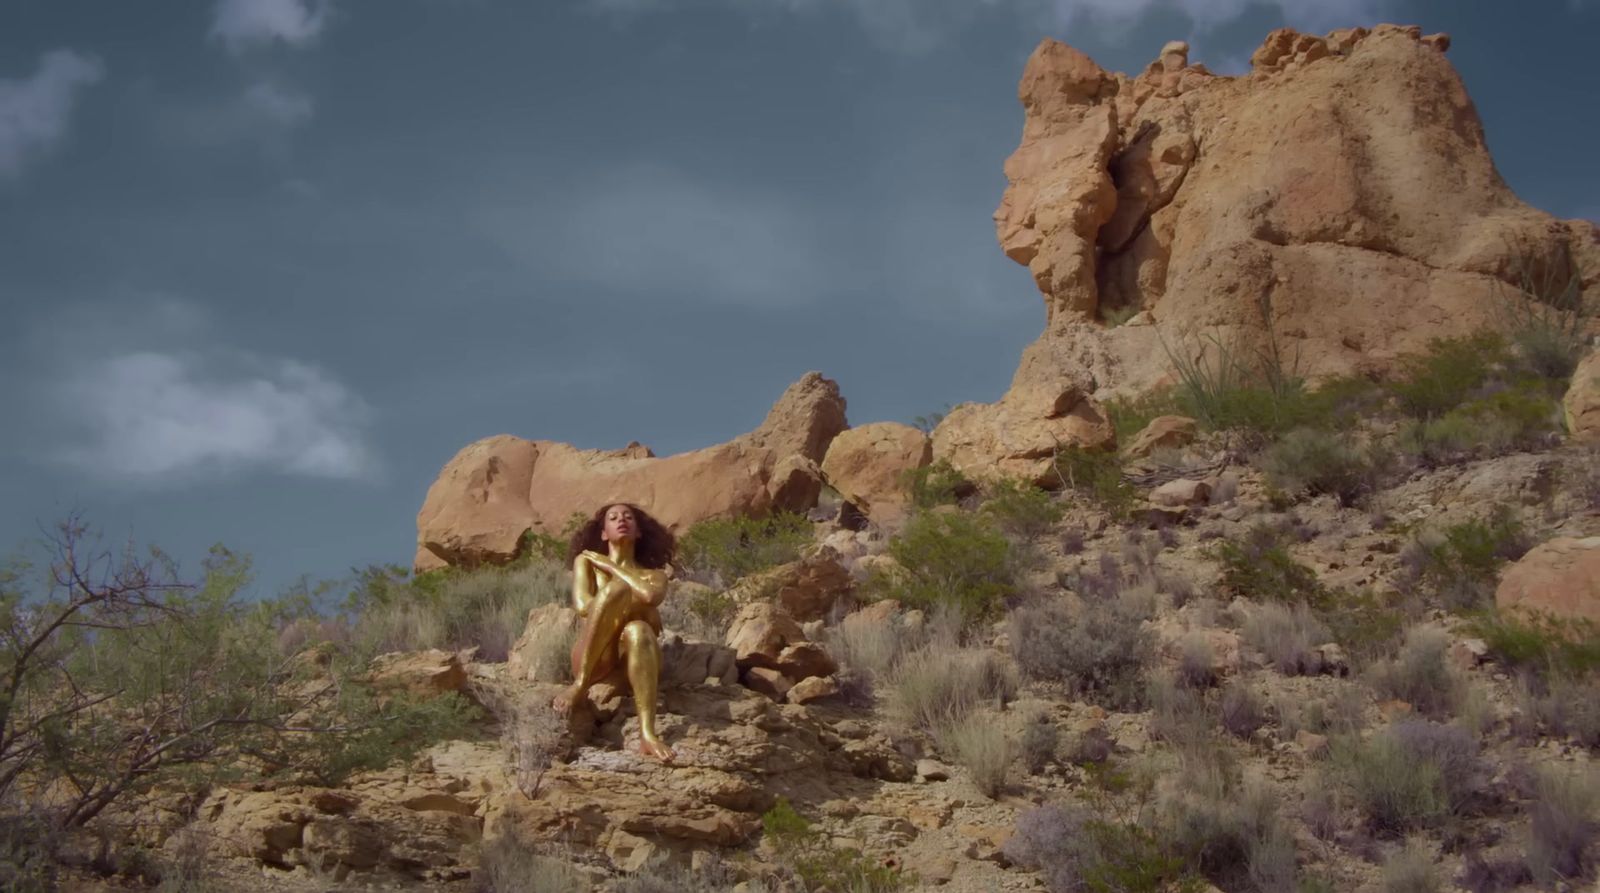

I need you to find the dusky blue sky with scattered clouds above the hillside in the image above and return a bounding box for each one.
[0,0,1600,594]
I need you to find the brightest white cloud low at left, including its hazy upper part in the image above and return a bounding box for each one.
[16,294,381,487]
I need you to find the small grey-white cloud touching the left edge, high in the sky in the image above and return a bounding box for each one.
[0,50,104,176]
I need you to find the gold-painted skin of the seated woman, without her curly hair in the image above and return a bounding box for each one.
[557,504,672,762]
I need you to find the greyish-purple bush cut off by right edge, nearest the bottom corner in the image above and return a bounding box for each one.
[1528,770,1600,887]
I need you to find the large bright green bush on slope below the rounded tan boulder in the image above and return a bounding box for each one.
[869,512,1016,619]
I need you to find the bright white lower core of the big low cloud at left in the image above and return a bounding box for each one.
[59,352,376,483]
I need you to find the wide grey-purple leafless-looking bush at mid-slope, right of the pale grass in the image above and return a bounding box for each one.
[1010,599,1155,709]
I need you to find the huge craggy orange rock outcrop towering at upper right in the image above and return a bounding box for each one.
[985,26,1600,403]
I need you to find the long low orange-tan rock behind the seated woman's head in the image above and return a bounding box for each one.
[416,373,845,571]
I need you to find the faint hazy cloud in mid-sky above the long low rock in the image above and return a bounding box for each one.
[480,165,824,306]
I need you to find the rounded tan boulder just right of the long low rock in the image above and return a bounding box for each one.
[822,422,933,523]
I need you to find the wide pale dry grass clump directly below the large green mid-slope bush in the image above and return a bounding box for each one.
[890,648,1016,739]
